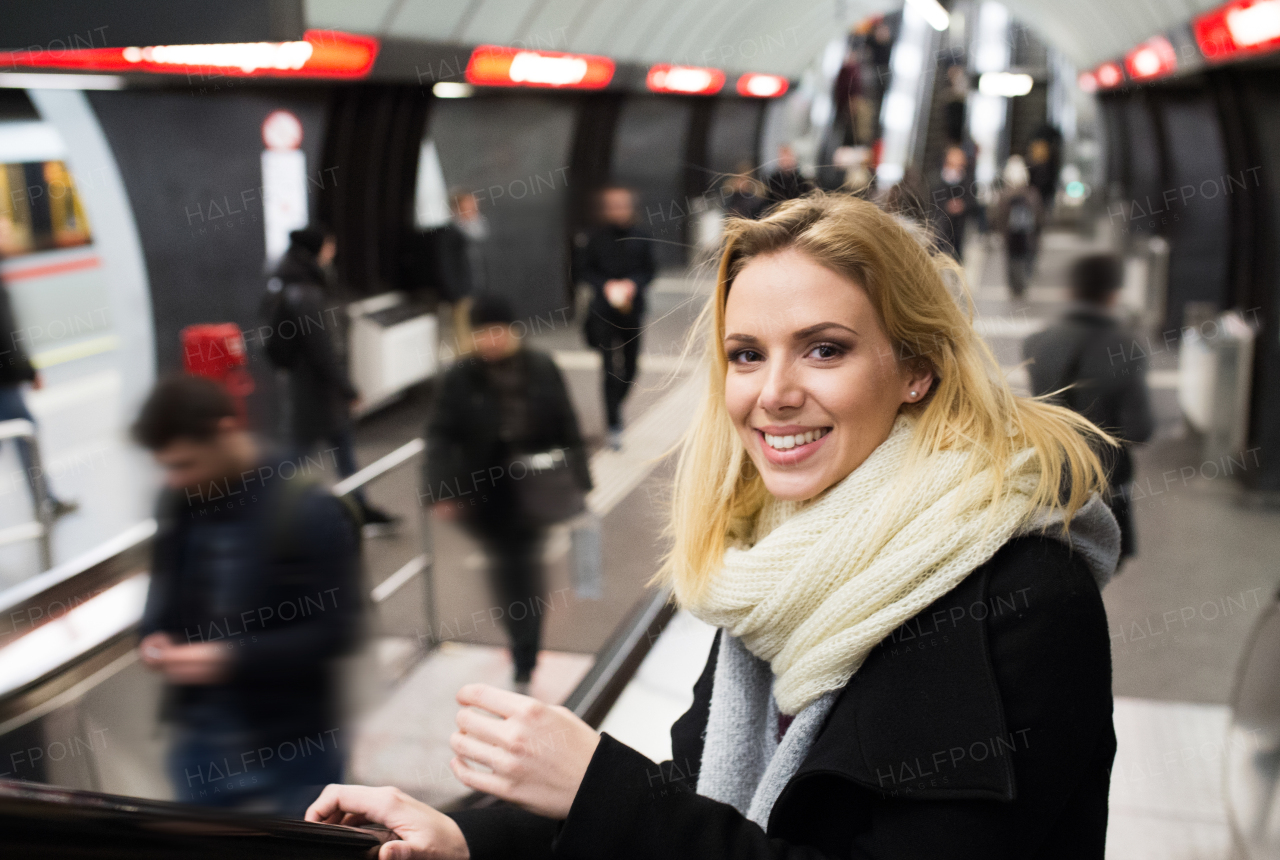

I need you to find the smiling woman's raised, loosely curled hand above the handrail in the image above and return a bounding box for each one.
[449,683,600,819]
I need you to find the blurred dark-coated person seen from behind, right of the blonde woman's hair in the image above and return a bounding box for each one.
[1023,253,1156,561]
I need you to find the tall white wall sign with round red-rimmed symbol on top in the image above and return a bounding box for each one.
[262,110,310,267]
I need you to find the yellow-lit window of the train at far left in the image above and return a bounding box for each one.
[0,161,91,257]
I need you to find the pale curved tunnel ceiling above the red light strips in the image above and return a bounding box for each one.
[306,0,1221,78]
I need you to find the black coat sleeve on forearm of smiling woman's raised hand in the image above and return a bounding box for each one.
[556,733,828,860]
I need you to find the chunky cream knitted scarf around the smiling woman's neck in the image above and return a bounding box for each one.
[677,416,1115,714]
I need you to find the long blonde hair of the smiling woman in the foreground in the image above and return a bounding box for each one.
[657,193,1115,595]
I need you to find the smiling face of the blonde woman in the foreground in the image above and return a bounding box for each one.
[724,250,933,502]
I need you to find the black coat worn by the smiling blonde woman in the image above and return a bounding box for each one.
[454,538,1115,860]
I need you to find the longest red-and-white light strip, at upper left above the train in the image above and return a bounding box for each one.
[0,29,378,78]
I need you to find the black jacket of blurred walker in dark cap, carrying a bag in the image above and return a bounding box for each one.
[422,348,591,517]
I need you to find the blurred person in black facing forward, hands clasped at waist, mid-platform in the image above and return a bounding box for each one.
[579,186,655,449]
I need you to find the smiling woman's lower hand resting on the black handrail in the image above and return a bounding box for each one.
[307,786,471,860]
